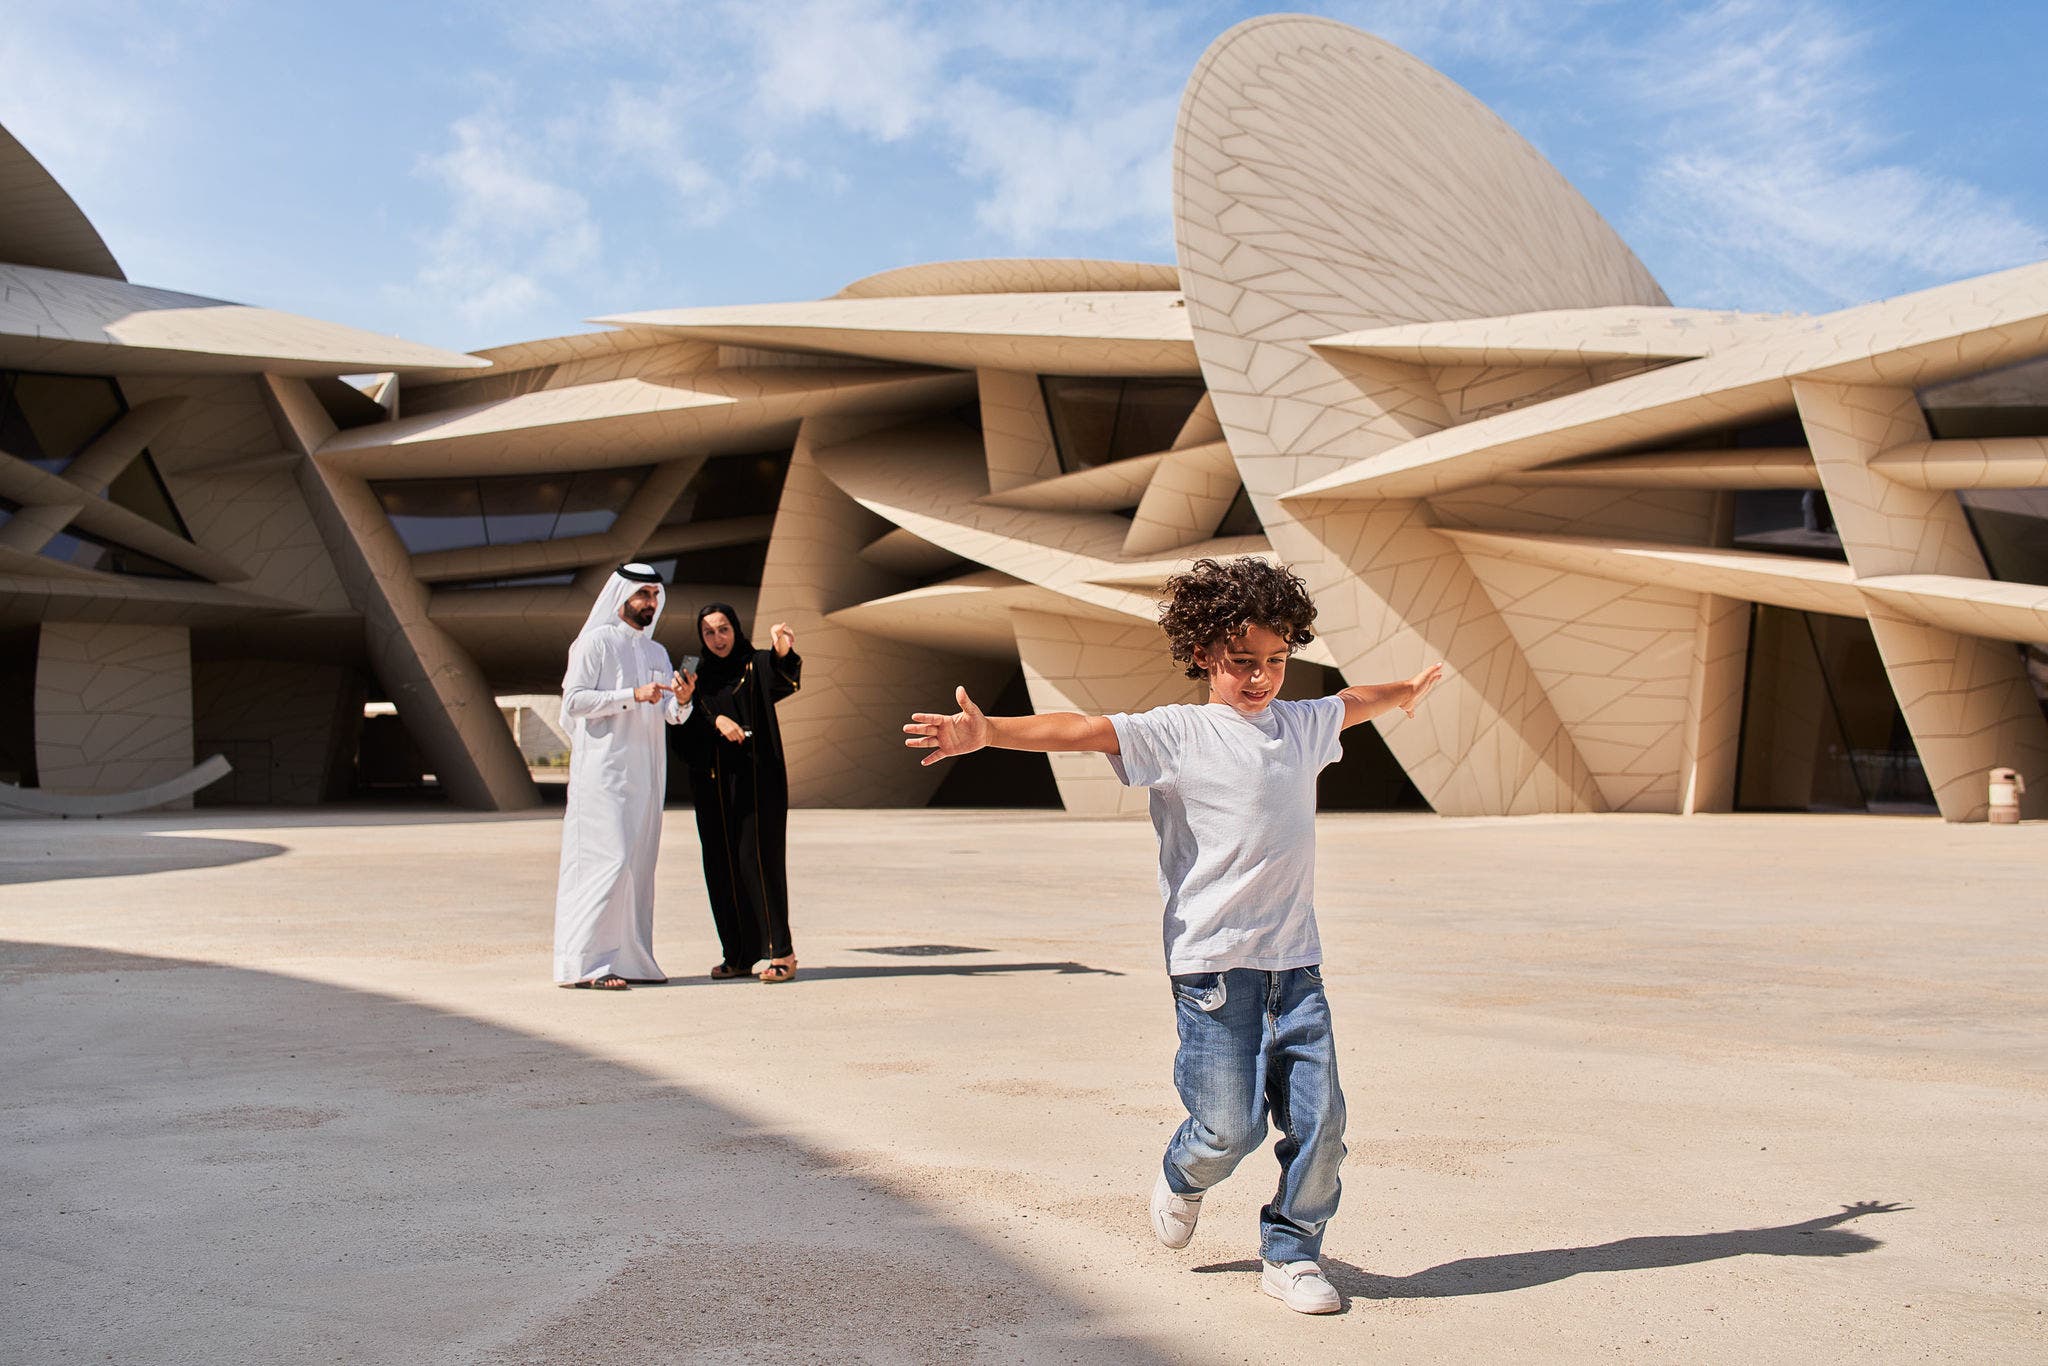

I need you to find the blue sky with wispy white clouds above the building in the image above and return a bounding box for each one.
[0,0,2048,348]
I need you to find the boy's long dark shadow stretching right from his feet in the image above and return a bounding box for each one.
[1194,1200,1911,1300]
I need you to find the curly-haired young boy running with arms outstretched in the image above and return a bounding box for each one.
[903,555,1444,1313]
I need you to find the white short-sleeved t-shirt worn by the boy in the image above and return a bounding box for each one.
[1110,696,1343,975]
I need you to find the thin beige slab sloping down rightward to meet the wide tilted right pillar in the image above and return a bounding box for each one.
[1438,528,1866,616]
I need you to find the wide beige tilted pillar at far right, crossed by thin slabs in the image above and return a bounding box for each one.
[1792,379,2048,821]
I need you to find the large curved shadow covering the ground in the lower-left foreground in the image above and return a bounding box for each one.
[0,942,1161,1366]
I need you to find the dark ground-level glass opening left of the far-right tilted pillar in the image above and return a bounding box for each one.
[1735,604,1935,811]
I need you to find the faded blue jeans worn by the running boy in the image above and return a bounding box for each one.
[1165,967,1343,1262]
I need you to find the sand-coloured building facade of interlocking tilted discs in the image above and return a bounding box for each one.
[0,16,2048,821]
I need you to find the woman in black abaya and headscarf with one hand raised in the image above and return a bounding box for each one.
[670,602,803,983]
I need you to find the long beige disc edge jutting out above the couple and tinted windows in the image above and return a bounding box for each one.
[319,367,975,477]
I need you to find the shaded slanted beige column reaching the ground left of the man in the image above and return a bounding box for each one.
[276,377,541,811]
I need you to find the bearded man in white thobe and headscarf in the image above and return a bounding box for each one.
[555,565,696,991]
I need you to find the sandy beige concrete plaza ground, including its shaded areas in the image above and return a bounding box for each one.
[0,811,2048,1366]
